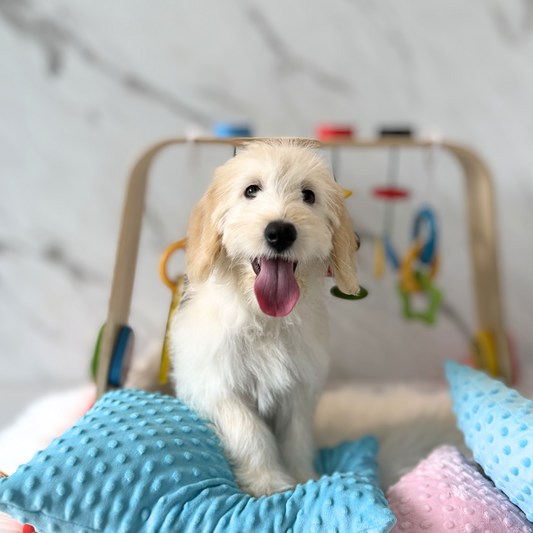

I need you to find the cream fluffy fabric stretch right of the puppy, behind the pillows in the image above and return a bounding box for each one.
[315,382,471,489]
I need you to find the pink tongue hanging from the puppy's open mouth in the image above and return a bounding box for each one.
[254,259,300,317]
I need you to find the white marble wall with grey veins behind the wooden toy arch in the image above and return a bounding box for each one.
[0,0,533,425]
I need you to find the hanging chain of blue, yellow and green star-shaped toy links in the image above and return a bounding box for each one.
[398,207,443,324]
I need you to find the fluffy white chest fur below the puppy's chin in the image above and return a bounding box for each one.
[171,276,328,416]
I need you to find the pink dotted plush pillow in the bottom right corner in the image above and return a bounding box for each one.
[387,446,533,533]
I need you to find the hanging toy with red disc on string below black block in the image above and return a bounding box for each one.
[372,128,412,279]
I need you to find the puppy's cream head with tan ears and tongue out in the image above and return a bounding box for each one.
[187,139,359,316]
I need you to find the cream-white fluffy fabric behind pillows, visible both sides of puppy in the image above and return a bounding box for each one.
[0,380,471,492]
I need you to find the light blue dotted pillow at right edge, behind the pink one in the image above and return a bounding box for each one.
[446,362,533,521]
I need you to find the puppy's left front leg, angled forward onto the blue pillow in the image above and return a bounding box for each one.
[213,397,296,498]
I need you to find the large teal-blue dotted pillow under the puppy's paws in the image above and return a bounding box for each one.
[0,390,390,533]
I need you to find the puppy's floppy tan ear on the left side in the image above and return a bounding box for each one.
[186,188,222,282]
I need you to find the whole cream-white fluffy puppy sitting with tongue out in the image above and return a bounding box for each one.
[169,139,359,497]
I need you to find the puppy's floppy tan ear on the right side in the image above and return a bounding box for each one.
[331,191,359,295]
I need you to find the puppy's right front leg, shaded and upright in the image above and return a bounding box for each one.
[276,390,318,484]
